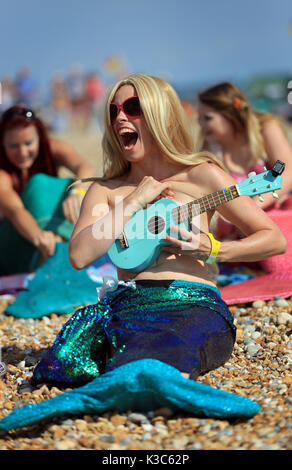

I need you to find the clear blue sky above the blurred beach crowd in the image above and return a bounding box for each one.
[0,0,292,96]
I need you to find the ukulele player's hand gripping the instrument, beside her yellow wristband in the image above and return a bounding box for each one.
[162,225,211,261]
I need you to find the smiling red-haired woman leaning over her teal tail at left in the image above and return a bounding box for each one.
[0,106,95,275]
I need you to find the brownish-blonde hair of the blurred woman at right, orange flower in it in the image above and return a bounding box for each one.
[198,82,278,168]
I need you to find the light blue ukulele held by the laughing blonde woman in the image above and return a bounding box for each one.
[108,160,285,272]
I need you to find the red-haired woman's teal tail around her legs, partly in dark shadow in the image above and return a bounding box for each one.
[0,173,73,276]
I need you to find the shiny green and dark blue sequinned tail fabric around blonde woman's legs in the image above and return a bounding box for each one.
[32,280,235,386]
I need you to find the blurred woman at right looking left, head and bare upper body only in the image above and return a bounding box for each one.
[198,82,292,204]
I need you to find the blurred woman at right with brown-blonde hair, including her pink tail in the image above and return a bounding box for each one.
[198,82,292,273]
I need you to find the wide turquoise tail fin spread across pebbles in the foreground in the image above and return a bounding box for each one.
[0,359,261,433]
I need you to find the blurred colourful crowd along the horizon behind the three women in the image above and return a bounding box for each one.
[0,61,292,134]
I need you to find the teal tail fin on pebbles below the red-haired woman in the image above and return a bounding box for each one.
[6,242,98,318]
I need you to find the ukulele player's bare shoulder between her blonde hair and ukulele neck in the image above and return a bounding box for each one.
[187,162,236,193]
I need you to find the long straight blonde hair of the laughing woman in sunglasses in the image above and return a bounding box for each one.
[102,74,223,179]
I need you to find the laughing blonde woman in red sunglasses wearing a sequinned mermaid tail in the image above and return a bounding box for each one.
[33,74,285,385]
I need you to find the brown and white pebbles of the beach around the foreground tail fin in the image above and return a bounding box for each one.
[0,298,292,451]
